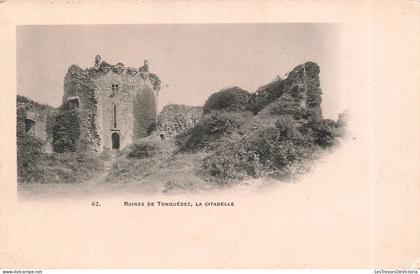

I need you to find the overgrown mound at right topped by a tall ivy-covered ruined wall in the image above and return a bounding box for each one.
[173,62,344,184]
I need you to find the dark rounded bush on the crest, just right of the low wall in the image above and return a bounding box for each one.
[203,87,251,114]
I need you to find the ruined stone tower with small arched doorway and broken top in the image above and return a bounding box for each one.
[62,55,160,151]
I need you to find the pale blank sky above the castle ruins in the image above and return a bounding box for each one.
[16,23,346,119]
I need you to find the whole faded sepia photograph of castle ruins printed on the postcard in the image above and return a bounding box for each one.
[16,23,349,196]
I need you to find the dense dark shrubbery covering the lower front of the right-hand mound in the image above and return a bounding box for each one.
[202,117,341,185]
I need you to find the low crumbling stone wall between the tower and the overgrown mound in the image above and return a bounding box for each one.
[158,105,203,137]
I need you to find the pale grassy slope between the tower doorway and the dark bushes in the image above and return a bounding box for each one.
[105,137,210,192]
